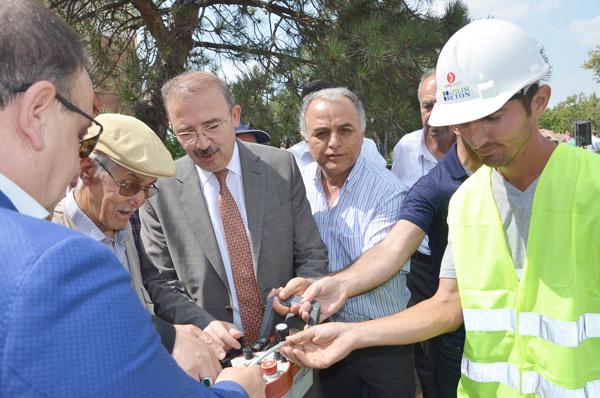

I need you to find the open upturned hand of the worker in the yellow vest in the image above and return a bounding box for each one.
[279,322,357,369]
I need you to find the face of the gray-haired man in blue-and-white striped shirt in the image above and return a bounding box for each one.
[306,97,364,178]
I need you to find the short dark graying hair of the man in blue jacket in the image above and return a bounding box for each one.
[0,0,88,109]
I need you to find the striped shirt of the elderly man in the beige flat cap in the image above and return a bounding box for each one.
[65,189,133,286]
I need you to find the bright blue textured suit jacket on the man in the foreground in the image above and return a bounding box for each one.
[0,191,247,397]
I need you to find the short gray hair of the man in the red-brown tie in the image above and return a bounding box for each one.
[161,71,235,113]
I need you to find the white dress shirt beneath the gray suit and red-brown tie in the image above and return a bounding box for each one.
[196,142,250,333]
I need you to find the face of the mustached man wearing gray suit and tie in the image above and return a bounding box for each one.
[167,84,241,173]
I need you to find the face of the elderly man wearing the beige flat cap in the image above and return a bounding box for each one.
[86,162,157,238]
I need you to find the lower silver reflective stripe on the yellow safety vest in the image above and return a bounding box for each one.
[461,357,600,398]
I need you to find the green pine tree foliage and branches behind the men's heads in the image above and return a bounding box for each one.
[44,0,468,157]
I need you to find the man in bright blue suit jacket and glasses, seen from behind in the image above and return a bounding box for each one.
[0,0,265,397]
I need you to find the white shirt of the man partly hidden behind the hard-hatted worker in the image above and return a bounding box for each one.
[392,129,437,255]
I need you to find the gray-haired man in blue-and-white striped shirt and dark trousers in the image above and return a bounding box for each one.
[300,88,415,397]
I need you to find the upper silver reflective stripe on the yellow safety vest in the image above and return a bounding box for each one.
[463,308,600,346]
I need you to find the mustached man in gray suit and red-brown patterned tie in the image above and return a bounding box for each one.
[140,72,327,350]
